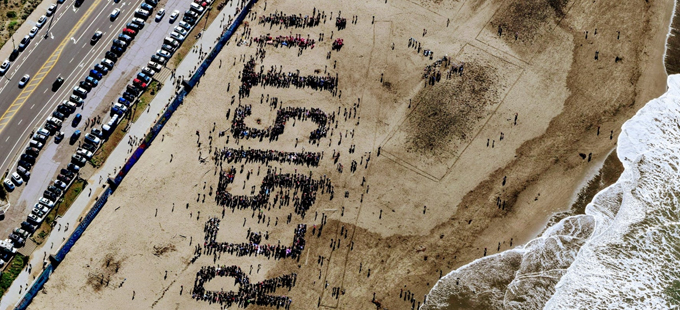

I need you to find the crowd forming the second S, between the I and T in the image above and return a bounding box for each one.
[231,104,328,143]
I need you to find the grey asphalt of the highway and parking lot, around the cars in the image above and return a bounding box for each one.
[0,0,197,235]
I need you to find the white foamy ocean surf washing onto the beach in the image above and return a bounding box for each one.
[421,75,680,310]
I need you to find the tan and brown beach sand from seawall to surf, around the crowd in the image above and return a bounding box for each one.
[31,0,672,309]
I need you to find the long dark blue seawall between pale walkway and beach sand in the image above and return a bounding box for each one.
[14,0,257,310]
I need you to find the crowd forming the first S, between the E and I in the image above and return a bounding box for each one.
[215,167,334,218]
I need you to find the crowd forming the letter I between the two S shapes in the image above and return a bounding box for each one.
[215,147,321,167]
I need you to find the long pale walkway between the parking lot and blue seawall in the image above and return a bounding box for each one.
[0,1,242,310]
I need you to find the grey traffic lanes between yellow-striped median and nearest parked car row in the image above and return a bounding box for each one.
[0,1,149,171]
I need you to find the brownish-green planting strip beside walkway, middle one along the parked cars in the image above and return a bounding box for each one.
[90,81,162,167]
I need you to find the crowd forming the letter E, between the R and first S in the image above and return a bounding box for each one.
[203,218,307,259]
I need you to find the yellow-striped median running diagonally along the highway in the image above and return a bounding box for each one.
[0,0,102,133]
